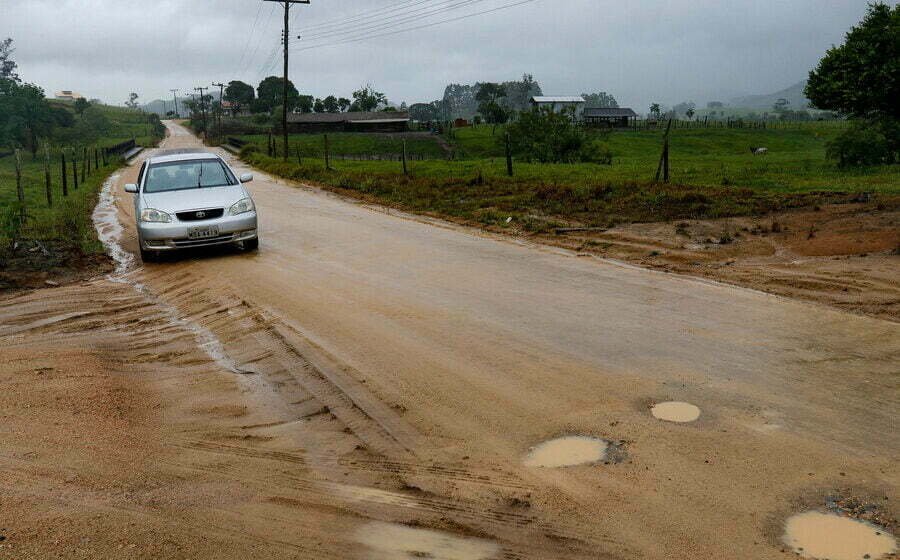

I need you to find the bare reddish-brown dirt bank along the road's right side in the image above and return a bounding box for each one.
[538,200,900,321]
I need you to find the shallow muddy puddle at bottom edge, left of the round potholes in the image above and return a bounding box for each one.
[356,521,500,560]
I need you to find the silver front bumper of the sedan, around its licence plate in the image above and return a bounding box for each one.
[137,212,257,251]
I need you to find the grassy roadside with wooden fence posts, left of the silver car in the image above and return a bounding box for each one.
[0,107,159,290]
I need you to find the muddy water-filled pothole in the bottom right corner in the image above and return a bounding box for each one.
[782,511,897,560]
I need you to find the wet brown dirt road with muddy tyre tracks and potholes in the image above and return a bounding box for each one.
[0,120,900,560]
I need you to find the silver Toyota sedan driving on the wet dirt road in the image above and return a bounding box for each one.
[125,150,259,261]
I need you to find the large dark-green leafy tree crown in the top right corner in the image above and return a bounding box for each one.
[804,3,900,120]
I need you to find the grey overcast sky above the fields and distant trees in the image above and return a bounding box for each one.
[0,0,866,111]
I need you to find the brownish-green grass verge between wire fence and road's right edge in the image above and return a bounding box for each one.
[242,149,880,233]
